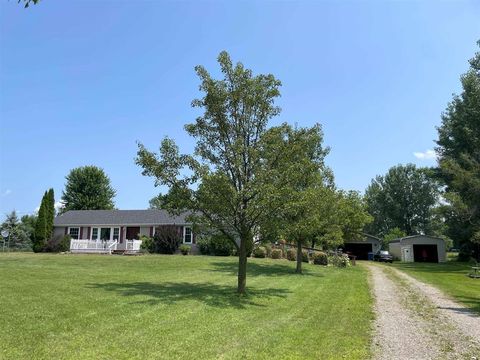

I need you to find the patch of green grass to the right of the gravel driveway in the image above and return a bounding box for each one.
[393,261,480,313]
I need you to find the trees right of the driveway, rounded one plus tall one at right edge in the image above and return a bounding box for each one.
[365,41,480,260]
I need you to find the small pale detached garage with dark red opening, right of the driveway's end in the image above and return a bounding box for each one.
[389,235,447,263]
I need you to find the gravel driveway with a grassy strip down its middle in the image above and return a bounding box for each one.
[367,263,480,360]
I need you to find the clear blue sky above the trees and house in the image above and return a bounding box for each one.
[0,0,480,217]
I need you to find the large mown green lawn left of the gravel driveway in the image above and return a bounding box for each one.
[0,254,374,359]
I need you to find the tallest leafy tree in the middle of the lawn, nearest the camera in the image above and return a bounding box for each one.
[136,52,318,293]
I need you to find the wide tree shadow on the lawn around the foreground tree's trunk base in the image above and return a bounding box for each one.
[87,282,290,309]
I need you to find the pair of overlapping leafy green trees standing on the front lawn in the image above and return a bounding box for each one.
[136,52,369,293]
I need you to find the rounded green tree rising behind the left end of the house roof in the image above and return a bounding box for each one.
[62,166,116,211]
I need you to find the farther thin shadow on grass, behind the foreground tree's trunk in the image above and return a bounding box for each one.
[210,260,324,278]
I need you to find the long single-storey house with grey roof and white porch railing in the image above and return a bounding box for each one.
[54,210,195,253]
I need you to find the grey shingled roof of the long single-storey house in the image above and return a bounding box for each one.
[54,209,188,226]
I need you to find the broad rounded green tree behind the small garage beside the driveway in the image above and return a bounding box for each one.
[365,164,439,237]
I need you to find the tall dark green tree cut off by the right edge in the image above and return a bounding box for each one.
[436,41,480,257]
